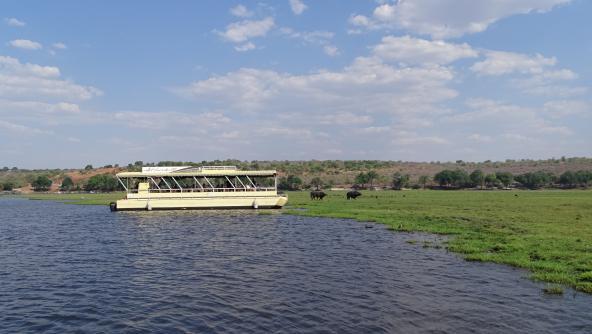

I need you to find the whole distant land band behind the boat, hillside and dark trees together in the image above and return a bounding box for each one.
[0,157,592,191]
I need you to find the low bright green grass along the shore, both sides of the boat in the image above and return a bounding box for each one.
[13,190,592,293]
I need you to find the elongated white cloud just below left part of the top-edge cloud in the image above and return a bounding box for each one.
[373,36,479,64]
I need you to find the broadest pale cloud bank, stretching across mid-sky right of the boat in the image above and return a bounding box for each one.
[176,57,456,114]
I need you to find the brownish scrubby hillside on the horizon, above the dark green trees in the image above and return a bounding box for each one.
[0,157,592,192]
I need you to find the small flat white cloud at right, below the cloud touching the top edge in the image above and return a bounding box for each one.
[471,51,557,75]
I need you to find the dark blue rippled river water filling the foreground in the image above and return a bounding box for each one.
[0,199,592,333]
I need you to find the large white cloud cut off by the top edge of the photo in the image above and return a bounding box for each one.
[350,0,571,39]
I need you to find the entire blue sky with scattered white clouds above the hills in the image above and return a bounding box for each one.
[0,0,592,168]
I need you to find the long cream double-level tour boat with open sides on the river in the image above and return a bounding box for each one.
[110,166,288,211]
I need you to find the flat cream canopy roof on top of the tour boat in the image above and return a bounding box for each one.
[117,166,277,177]
